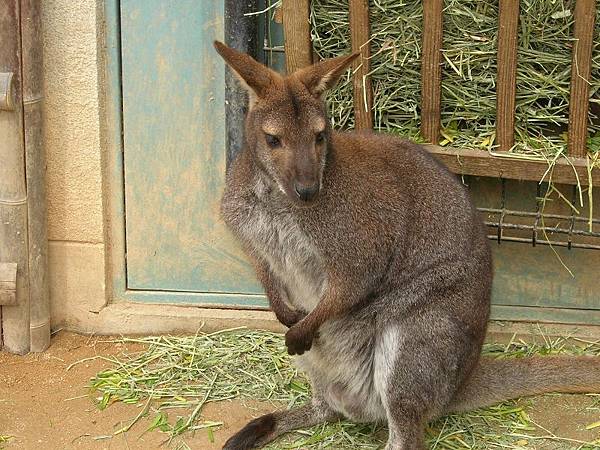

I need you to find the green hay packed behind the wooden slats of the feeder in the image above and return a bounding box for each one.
[311,0,600,158]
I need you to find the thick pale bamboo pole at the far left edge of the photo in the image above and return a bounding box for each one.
[0,0,30,354]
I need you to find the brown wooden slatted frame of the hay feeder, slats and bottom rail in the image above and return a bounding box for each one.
[282,0,600,186]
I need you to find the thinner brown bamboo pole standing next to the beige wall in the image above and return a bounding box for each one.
[21,0,50,352]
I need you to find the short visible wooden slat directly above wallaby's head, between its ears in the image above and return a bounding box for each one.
[281,0,312,73]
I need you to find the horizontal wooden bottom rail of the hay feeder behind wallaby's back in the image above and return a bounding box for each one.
[425,145,600,186]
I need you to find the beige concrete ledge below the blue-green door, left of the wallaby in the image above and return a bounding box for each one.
[64,302,286,335]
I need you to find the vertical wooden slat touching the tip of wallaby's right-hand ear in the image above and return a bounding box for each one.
[350,0,373,130]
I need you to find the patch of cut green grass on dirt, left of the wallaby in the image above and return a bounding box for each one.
[85,329,309,437]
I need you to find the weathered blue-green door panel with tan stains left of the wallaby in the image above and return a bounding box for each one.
[120,0,264,305]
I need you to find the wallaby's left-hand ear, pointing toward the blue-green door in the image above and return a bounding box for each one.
[214,41,277,101]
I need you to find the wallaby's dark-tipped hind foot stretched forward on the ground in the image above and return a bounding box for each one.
[223,399,339,450]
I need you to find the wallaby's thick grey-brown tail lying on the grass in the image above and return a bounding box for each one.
[447,356,600,412]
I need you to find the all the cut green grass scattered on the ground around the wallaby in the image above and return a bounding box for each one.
[85,329,600,450]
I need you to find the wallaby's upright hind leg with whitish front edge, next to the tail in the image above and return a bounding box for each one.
[375,312,479,450]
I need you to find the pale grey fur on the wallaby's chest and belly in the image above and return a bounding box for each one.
[244,208,395,422]
